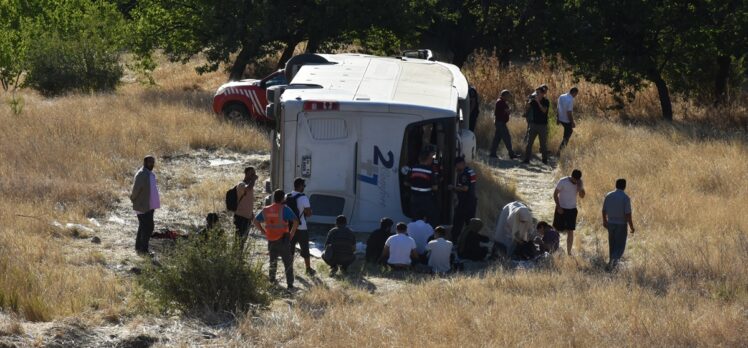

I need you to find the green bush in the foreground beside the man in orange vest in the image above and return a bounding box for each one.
[138,231,269,314]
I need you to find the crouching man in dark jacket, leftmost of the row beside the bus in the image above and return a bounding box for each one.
[322,215,356,275]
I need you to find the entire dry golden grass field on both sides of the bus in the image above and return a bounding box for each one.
[0,53,748,347]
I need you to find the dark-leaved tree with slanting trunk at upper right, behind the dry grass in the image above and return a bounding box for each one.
[548,0,700,120]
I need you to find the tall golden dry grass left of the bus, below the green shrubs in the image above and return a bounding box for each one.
[0,55,266,320]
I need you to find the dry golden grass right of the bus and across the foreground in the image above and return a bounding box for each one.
[235,51,748,347]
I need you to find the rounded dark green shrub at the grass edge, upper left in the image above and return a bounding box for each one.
[25,39,123,96]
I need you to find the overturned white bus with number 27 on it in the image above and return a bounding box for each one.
[267,54,475,232]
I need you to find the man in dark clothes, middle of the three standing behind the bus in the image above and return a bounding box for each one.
[524,85,551,164]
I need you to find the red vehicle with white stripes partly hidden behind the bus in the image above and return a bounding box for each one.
[213,70,287,122]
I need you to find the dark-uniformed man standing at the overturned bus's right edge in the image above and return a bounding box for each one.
[452,156,478,244]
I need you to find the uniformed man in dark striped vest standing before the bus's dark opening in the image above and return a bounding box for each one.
[406,150,439,223]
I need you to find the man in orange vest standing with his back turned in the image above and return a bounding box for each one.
[254,190,299,290]
